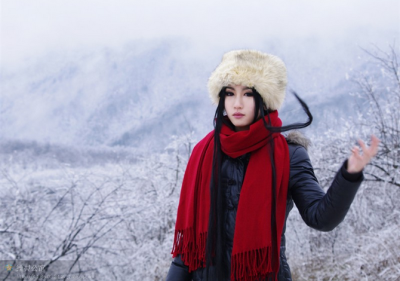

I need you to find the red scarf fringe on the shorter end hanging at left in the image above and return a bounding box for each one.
[171,227,207,272]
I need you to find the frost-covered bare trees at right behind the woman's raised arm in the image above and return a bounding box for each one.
[288,46,400,280]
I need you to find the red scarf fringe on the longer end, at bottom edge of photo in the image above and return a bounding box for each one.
[231,247,276,281]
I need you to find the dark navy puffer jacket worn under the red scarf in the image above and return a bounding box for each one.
[166,139,363,281]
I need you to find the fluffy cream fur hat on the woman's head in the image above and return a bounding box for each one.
[208,50,287,110]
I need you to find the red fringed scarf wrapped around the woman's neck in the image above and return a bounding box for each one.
[172,111,289,281]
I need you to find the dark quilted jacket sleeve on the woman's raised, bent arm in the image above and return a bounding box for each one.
[289,145,363,231]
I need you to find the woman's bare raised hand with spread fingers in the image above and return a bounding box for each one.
[347,135,379,173]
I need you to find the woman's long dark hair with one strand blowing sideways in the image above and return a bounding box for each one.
[205,87,313,280]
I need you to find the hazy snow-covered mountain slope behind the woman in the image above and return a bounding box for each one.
[0,37,382,152]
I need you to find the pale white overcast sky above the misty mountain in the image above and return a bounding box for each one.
[0,0,400,67]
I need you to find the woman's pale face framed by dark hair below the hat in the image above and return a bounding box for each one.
[225,84,255,131]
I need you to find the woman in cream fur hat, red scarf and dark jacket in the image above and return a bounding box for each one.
[167,50,379,281]
